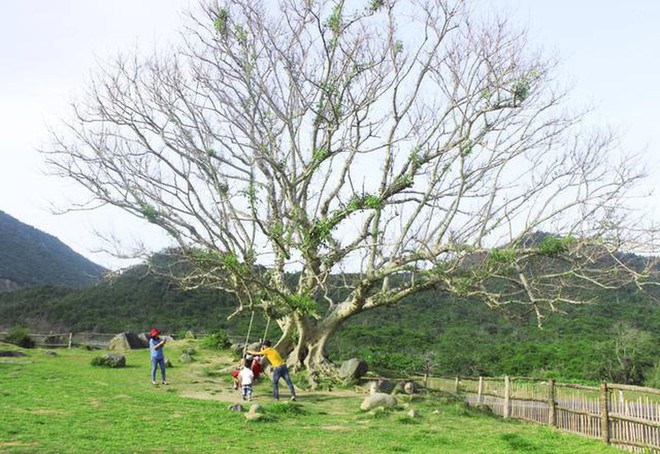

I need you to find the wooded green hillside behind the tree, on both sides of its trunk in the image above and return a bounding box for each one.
[0,258,660,386]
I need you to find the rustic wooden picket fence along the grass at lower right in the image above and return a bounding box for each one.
[428,376,660,453]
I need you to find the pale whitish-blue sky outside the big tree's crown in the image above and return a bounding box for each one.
[0,0,660,268]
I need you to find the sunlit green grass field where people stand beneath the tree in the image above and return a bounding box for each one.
[0,341,621,454]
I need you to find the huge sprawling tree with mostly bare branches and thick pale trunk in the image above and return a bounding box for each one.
[45,0,652,376]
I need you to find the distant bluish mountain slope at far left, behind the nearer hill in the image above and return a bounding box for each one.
[0,211,107,291]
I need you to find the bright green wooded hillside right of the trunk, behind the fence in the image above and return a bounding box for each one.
[333,284,660,386]
